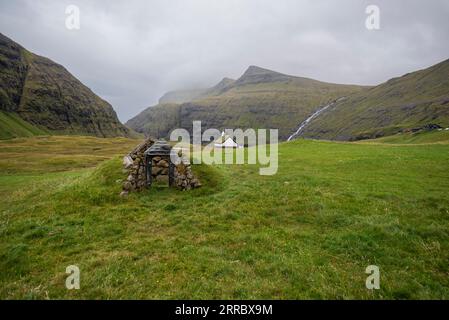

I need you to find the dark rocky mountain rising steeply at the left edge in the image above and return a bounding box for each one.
[0,33,132,137]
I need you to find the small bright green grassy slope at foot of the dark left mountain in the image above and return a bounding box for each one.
[0,111,50,139]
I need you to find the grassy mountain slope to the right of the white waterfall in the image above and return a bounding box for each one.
[302,60,449,140]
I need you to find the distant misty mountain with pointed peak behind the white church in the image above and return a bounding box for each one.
[126,66,365,140]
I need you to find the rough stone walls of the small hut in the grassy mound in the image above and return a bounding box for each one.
[120,138,201,196]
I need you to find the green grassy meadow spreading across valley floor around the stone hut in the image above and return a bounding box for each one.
[0,137,449,299]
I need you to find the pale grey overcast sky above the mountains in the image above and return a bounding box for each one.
[0,0,449,122]
